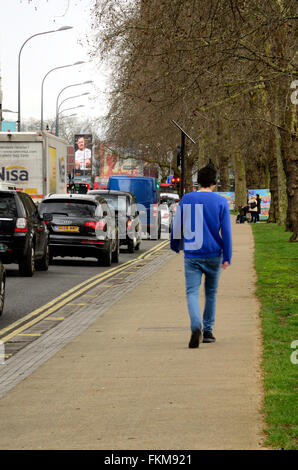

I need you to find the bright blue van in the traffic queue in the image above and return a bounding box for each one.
[108,176,161,238]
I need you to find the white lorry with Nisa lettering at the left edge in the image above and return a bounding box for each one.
[0,132,67,203]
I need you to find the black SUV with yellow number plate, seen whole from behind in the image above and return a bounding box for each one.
[39,194,119,266]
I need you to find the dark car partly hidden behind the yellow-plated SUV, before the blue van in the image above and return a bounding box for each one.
[88,189,142,253]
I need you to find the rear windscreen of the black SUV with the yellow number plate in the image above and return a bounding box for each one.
[39,199,97,217]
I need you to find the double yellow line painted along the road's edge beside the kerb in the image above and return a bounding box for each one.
[0,240,168,343]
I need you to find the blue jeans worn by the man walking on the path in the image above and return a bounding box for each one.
[184,256,222,332]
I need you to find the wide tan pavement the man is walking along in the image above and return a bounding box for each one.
[0,223,263,450]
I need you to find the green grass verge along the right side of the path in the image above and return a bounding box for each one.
[252,224,298,450]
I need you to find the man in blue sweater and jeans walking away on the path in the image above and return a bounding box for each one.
[171,164,232,348]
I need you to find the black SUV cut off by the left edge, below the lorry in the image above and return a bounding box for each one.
[0,191,49,277]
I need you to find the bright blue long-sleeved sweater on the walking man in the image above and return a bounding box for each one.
[171,191,232,263]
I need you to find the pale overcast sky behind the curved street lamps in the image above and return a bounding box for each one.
[0,0,108,129]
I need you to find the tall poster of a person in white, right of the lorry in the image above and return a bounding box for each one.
[74,134,92,178]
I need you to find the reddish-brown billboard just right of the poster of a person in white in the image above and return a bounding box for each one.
[99,143,139,179]
